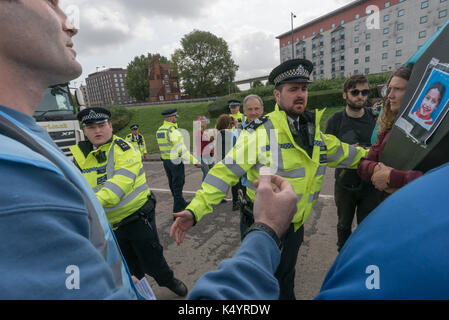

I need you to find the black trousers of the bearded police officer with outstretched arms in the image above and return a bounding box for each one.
[240,212,304,300]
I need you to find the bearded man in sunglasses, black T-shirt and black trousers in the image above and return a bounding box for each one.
[326,75,379,251]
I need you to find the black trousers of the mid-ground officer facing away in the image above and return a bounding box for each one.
[163,160,187,212]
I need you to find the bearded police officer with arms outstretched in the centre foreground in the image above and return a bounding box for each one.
[170,59,367,299]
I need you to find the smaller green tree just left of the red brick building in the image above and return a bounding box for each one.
[125,53,169,101]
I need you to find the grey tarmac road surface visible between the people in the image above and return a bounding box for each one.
[144,161,337,300]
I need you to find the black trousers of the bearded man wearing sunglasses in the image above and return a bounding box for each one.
[334,183,380,251]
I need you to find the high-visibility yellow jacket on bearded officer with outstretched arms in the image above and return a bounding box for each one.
[187,105,368,231]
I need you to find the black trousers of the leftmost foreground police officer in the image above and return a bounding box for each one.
[114,199,174,287]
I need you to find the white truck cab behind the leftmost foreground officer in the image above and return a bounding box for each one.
[34,83,84,157]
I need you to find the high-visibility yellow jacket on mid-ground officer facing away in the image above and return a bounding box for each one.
[156,121,199,164]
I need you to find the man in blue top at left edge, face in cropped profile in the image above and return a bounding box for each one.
[0,0,136,299]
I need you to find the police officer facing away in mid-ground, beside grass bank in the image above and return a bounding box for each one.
[156,108,202,212]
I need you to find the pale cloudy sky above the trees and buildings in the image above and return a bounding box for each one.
[60,0,354,87]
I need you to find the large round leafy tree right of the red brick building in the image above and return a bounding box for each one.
[172,30,238,98]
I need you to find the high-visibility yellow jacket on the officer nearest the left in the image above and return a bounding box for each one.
[70,135,150,226]
